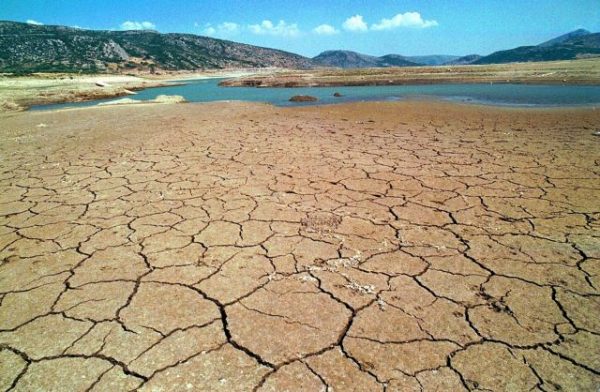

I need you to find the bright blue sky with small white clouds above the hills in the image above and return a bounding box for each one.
[0,0,600,56]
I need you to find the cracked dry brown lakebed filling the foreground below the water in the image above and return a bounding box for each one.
[0,102,600,392]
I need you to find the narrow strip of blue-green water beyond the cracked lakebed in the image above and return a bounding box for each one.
[32,79,600,110]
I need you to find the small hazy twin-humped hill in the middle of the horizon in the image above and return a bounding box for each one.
[312,50,421,68]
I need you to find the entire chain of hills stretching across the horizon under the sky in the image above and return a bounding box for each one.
[0,21,600,73]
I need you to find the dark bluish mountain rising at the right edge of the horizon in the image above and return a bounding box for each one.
[473,32,600,64]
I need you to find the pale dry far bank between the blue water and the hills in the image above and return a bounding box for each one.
[0,59,600,112]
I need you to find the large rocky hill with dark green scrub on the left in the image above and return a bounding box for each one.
[0,21,313,72]
